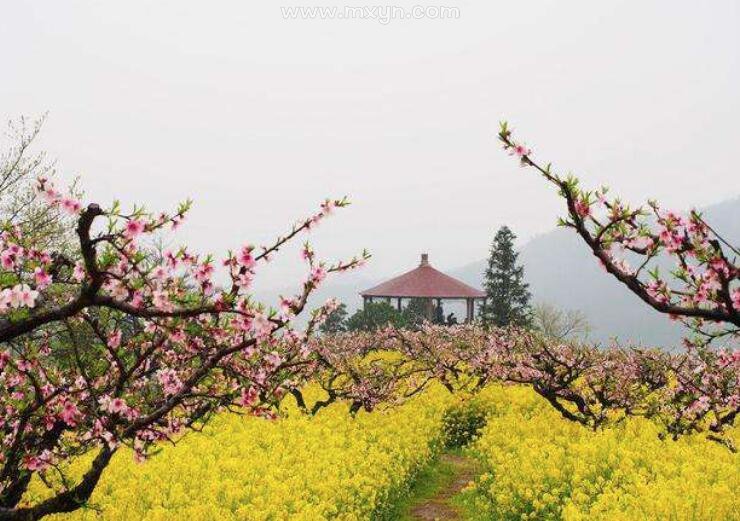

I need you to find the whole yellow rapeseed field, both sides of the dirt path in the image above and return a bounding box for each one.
[24,380,740,521]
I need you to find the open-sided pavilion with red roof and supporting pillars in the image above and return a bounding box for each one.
[360,253,486,322]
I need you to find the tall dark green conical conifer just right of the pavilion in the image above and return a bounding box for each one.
[480,226,531,327]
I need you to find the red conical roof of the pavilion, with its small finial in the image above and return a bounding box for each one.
[360,253,486,298]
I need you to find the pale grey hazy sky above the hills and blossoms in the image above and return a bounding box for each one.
[0,0,740,296]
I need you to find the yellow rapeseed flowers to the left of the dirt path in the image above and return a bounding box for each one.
[26,387,452,521]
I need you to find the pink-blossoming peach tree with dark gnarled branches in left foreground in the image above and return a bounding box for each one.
[0,178,368,520]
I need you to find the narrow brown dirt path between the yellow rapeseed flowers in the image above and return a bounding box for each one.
[410,454,480,521]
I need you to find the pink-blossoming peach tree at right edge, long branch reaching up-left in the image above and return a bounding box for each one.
[499,122,740,440]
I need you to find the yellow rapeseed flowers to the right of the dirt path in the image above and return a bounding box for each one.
[469,387,740,521]
